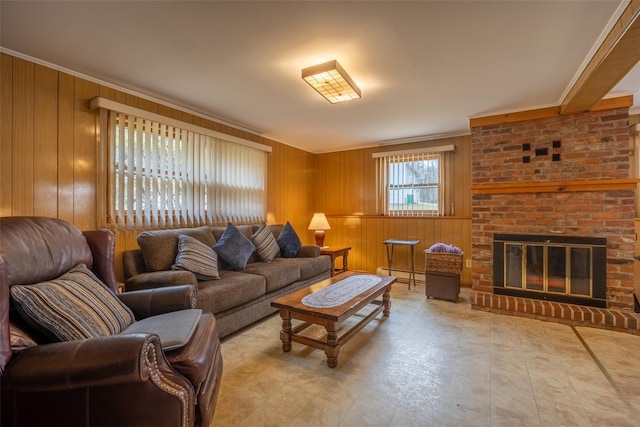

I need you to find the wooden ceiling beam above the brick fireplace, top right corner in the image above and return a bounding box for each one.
[560,0,640,114]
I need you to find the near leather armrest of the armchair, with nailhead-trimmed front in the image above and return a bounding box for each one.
[2,334,190,392]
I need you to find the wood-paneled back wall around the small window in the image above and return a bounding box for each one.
[314,136,471,285]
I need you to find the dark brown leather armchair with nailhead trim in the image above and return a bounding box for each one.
[0,217,222,427]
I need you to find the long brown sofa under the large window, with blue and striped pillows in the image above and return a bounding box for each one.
[123,224,331,338]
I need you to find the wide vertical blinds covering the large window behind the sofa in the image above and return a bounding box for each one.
[107,111,267,230]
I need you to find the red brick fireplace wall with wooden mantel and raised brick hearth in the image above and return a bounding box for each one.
[464,100,640,333]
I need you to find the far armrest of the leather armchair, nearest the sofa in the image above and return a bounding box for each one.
[117,285,197,320]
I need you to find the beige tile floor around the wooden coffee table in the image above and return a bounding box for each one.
[214,283,640,427]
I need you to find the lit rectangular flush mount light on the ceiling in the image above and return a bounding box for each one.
[302,59,361,104]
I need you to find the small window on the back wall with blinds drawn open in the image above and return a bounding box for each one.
[374,146,454,216]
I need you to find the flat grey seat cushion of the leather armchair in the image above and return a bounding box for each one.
[120,308,202,351]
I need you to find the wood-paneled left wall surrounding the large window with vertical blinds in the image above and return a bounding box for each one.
[0,54,314,279]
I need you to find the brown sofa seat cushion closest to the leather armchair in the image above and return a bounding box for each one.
[196,270,266,314]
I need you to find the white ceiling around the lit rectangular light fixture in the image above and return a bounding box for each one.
[0,0,640,153]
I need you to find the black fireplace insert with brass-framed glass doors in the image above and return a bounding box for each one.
[493,234,607,308]
